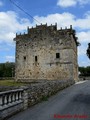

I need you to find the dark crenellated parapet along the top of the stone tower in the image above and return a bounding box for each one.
[14,23,78,45]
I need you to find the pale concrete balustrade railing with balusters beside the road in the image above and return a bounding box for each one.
[0,89,24,120]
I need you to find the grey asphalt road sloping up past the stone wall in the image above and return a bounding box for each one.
[8,81,90,120]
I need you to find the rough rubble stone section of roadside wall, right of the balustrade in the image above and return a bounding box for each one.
[28,80,75,106]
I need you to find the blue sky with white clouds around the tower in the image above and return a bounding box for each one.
[0,0,90,67]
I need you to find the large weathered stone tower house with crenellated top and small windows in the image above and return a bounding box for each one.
[14,24,78,81]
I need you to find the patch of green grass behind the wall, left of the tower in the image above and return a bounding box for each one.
[0,80,26,86]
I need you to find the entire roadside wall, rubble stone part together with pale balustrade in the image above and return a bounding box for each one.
[0,80,75,120]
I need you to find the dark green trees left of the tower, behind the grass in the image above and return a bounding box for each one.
[0,62,15,78]
